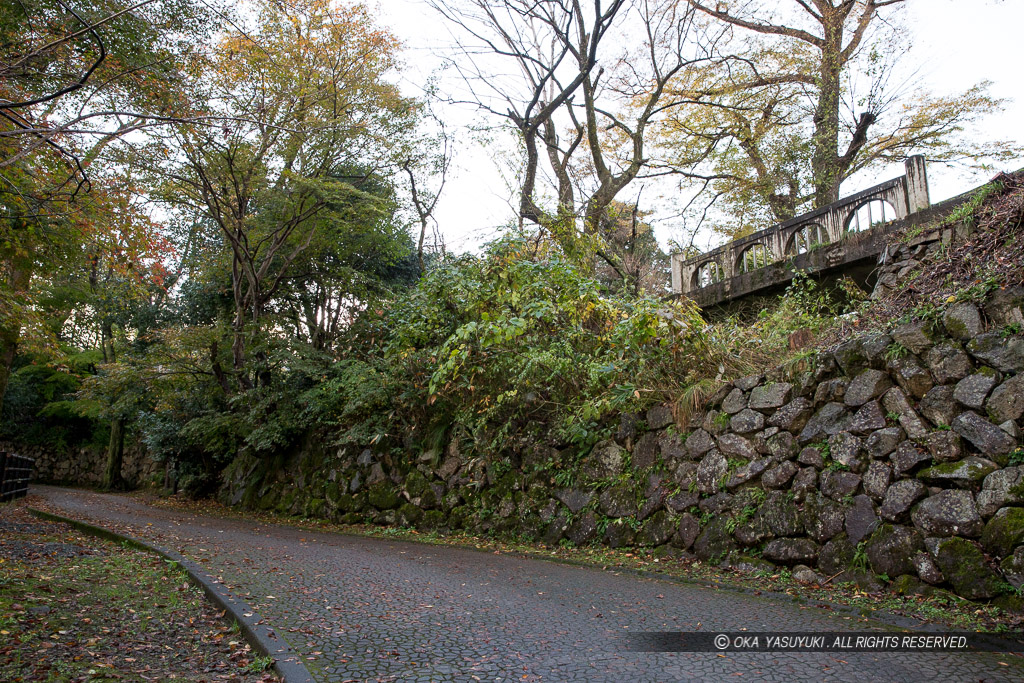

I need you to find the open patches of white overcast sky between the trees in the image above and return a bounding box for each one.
[378,0,1024,251]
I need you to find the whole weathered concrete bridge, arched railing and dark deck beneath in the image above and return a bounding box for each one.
[672,157,931,308]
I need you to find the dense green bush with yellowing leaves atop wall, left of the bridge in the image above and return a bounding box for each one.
[379,237,703,451]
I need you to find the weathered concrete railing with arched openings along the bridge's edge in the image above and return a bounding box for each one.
[672,157,931,294]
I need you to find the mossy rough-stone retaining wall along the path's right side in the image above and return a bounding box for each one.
[222,290,1024,602]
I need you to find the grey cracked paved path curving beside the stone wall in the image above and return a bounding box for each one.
[33,486,1024,683]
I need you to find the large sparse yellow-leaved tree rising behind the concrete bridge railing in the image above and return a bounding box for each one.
[659,0,1021,234]
